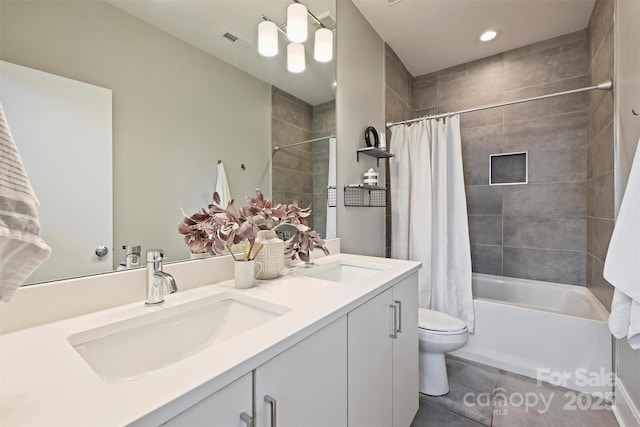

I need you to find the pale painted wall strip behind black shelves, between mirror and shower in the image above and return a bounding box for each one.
[336,0,385,256]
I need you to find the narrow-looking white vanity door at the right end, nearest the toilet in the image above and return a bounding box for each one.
[393,273,419,427]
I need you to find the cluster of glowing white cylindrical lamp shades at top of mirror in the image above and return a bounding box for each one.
[258,0,335,73]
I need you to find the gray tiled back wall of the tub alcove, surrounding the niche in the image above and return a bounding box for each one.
[386,30,592,285]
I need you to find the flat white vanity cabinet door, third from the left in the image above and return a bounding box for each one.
[348,289,394,427]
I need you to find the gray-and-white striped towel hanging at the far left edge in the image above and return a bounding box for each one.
[0,105,51,301]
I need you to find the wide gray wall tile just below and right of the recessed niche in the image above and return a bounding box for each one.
[503,182,586,217]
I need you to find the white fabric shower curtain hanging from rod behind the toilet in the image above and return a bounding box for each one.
[389,116,474,332]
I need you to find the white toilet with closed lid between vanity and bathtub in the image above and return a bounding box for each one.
[418,308,469,396]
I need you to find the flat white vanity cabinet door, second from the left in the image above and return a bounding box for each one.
[255,316,347,427]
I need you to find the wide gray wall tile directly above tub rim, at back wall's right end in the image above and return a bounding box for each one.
[503,246,587,286]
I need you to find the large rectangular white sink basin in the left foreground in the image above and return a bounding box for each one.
[68,292,289,383]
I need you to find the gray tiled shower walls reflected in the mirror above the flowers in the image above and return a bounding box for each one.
[271,86,336,236]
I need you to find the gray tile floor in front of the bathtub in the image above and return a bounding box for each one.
[411,358,618,427]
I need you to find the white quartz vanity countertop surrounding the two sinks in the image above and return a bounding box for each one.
[0,254,420,426]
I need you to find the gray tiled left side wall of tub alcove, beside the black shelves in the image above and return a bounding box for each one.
[384,43,414,257]
